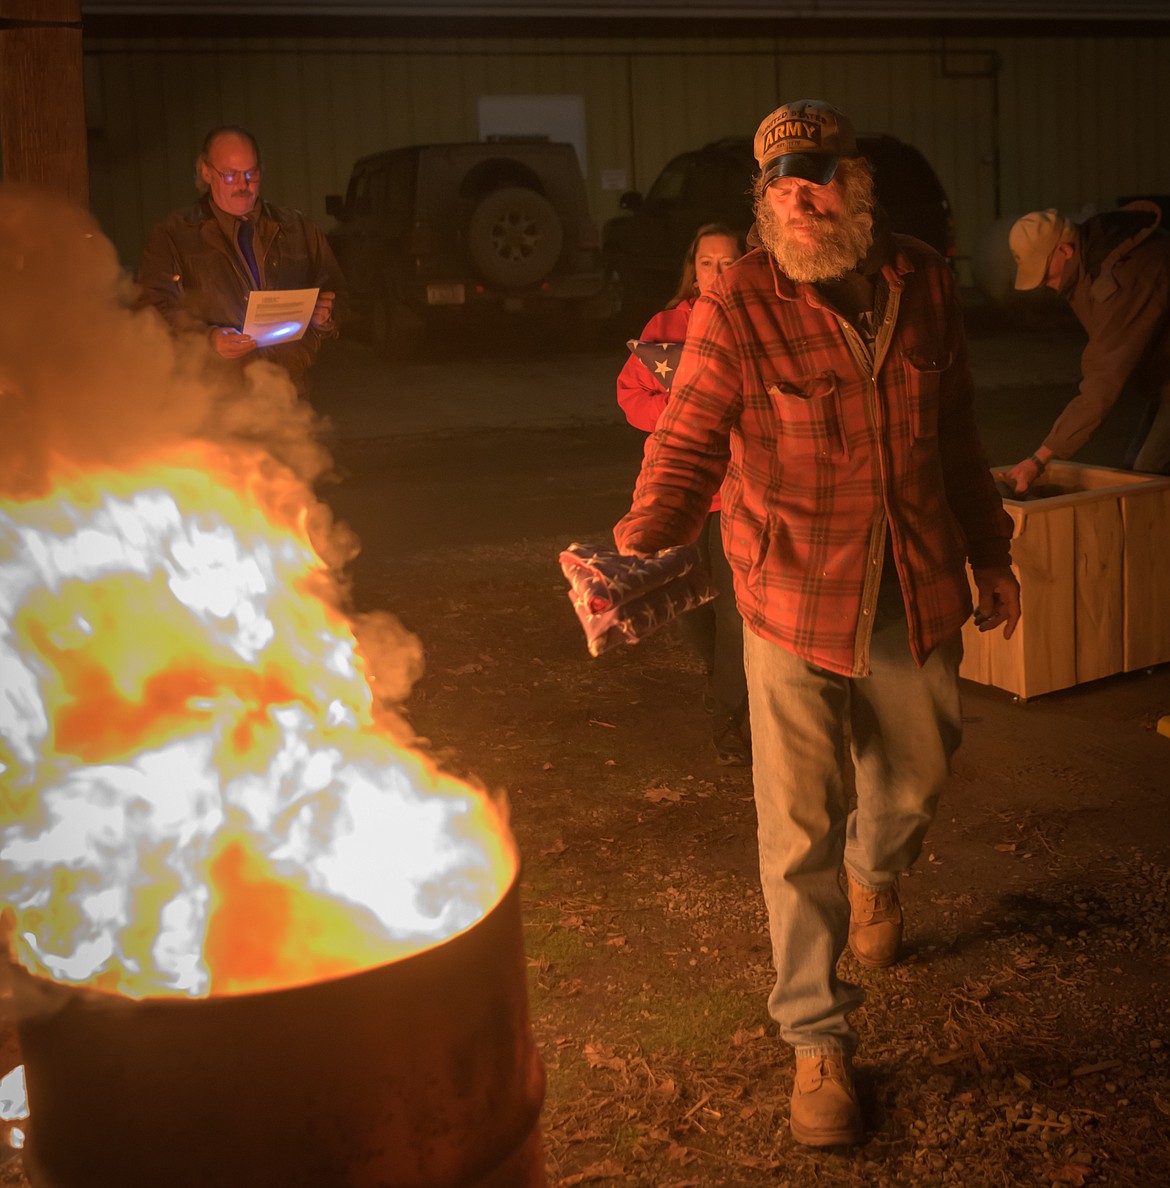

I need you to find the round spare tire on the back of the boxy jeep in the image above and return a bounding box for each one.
[467,185,564,289]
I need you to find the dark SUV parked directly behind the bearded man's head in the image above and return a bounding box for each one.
[602,135,955,334]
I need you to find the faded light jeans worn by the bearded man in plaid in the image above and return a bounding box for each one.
[744,582,962,1056]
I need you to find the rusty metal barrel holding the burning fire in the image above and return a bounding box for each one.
[13,881,545,1188]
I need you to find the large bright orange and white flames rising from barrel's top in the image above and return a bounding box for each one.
[0,443,517,997]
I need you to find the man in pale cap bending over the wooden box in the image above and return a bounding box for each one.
[1008,202,1170,494]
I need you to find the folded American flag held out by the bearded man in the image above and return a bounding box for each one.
[559,544,716,656]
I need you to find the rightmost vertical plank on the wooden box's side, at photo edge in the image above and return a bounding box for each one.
[1121,484,1170,672]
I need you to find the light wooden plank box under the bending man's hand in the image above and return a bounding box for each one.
[959,462,1170,699]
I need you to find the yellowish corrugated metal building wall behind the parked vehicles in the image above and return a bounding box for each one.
[86,36,1170,282]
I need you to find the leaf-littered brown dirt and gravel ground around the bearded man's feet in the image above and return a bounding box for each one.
[362,529,1170,1188]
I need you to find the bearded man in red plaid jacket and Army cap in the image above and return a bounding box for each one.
[614,100,1019,1146]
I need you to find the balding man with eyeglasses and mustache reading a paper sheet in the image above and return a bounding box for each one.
[138,125,344,393]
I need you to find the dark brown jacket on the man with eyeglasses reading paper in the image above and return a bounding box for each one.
[138,195,344,386]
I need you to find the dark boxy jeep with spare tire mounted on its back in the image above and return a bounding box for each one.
[325,139,616,356]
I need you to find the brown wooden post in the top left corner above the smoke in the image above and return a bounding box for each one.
[0,0,89,206]
